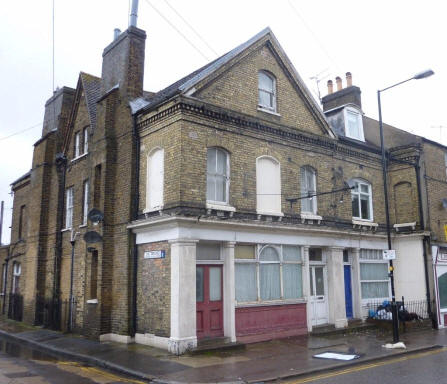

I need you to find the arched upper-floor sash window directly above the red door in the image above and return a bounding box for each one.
[206,148,230,204]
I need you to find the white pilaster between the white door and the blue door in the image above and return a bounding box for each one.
[327,247,348,328]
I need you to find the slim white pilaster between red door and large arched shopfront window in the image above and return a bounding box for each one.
[222,242,236,342]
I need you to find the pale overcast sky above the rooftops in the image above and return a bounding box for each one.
[0,0,447,243]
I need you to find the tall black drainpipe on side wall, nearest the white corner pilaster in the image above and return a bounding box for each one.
[130,114,140,336]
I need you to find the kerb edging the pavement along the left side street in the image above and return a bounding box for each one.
[0,329,156,381]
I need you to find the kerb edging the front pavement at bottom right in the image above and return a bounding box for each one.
[246,344,444,384]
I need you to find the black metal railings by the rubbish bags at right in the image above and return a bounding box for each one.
[366,297,433,322]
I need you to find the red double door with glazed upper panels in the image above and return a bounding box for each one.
[196,265,223,338]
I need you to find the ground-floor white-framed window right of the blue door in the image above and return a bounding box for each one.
[360,249,390,300]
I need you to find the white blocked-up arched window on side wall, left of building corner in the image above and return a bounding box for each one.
[146,148,164,211]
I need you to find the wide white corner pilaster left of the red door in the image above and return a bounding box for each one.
[168,239,197,355]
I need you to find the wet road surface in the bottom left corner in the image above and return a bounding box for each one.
[0,339,145,384]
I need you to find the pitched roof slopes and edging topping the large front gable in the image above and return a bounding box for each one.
[129,27,336,137]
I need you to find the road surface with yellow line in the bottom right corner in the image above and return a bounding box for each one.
[282,347,447,384]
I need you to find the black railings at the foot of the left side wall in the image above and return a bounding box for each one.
[35,296,76,331]
